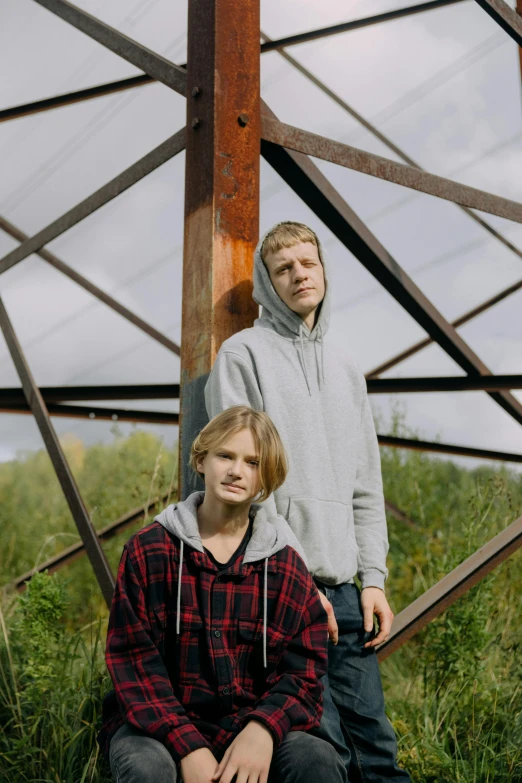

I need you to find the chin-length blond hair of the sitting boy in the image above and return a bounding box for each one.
[190,405,288,502]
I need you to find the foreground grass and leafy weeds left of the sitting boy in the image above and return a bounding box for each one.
[0,573,109,783]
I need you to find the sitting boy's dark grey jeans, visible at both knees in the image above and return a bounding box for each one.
[110,724,346,783]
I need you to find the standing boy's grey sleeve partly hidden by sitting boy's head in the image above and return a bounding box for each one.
[205,349,277,516]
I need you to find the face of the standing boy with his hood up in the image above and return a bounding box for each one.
[264,242,325,325]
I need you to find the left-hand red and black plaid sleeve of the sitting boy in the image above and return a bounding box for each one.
[105,548,210,762]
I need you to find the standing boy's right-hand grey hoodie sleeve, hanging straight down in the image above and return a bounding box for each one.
[353,380,388,590]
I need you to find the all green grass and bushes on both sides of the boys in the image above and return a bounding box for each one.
[0,422,522,783]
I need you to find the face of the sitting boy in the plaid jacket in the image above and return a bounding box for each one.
[197,429,261,506]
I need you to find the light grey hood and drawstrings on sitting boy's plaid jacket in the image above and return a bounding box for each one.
[154,492,308,667]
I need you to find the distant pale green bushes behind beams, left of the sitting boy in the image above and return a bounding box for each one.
[0,429,177,623]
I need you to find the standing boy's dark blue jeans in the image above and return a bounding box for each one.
[314,584,410,783]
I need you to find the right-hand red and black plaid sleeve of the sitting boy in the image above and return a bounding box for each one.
[242,550,328,747]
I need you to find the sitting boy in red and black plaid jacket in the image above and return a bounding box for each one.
[99,406,346,783]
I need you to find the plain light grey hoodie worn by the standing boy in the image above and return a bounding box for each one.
[205,225,388,588]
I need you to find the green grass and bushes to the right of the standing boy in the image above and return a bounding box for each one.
[381,416,522,783]
